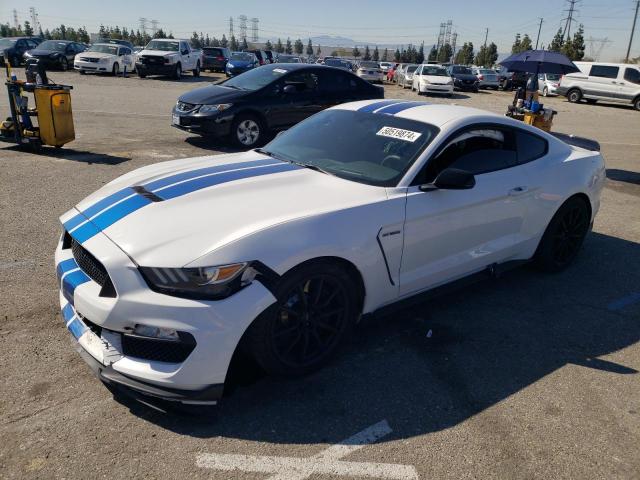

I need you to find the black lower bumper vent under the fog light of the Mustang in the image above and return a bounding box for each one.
[122,332,196,363]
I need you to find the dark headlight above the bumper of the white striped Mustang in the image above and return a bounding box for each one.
[140,262,257,300]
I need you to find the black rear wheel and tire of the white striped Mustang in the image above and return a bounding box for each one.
[534,197,591,273]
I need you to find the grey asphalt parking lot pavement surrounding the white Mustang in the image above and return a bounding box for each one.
[0,72,640,480]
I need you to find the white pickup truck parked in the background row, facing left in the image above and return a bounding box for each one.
[136,38,202,80]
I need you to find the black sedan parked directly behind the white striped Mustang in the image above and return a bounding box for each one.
[172,63,384,149]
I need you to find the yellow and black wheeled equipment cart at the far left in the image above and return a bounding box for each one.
[0,56,76,149]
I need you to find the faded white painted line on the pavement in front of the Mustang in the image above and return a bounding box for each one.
[196,420,418,480]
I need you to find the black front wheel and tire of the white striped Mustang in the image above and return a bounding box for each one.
[248,262,359,377]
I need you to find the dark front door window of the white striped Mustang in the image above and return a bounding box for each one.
[419,127,518,184]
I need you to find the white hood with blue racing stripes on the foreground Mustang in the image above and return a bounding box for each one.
[62,151,386,267]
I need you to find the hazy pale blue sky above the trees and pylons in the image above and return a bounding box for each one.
[0,0,640,61]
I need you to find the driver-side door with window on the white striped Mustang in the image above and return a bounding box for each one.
[400,125,527,296]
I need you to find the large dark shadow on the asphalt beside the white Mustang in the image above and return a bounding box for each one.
[112,234,640,444]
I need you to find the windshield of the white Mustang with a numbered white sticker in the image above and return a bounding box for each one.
[264,110,439,187]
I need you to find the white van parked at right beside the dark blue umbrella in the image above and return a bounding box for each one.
[557,62,640,110]
